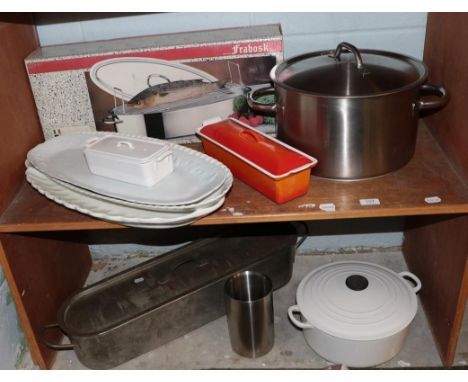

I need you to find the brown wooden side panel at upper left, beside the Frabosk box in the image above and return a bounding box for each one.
[0,13,43,213]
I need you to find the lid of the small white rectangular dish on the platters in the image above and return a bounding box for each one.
[85,135,172,163]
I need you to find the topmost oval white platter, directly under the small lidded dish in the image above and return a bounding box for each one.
[27,132,232,206]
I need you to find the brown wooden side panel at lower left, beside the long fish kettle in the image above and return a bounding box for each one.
[0,234,91,369]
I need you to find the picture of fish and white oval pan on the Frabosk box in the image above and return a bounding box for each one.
[85,56,276,139]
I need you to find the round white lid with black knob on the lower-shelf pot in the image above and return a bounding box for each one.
[296,261,417,340]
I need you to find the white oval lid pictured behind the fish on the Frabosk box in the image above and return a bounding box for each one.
[89,57,217,101]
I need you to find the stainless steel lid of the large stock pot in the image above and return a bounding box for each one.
[271,43,427,97]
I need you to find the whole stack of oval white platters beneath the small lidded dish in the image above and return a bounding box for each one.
[26,132,233,228]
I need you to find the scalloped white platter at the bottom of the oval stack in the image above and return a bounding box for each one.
[26,167,224,228]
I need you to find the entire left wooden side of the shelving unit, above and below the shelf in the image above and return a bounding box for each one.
[0,13,90,368]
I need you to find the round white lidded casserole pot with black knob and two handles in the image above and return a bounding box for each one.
[288,261,421,367]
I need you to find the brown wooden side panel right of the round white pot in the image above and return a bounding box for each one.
[403,215,468,366]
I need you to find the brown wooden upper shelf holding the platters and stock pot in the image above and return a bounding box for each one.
[0,125,468,233]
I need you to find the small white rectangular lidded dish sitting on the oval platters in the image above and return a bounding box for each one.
[84,135,173,187]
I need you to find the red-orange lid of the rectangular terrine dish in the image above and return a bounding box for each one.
[197,118,317,179]
